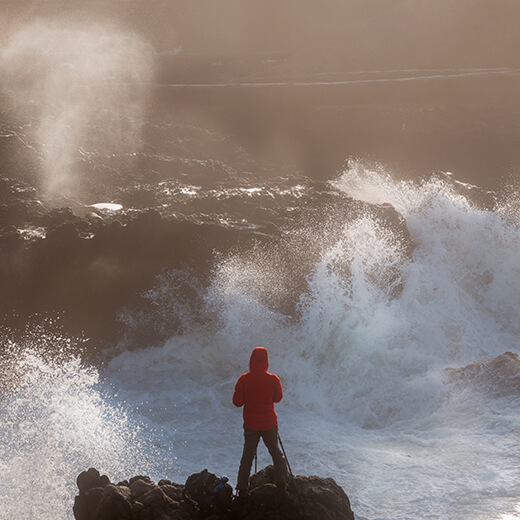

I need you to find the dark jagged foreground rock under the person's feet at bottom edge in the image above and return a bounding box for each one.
[74,466,354,520]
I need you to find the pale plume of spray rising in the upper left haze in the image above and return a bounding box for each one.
[0,21,154,198]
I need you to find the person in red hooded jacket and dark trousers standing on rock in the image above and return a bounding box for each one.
[233,347,289,495]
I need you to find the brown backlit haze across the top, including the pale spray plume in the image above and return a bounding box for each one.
[0,0,520,201]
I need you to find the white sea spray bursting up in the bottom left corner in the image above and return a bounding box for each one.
[0,334,153,520]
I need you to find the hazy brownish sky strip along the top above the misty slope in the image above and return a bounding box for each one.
[0,0,520,68]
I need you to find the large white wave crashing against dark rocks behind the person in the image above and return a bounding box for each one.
[114,163,520,429]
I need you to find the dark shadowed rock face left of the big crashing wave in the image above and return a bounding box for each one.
[0,203,254,338]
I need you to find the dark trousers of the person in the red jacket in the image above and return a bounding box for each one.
[237,426,289,491]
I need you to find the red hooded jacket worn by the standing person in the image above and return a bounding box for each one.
[233,347,283,431]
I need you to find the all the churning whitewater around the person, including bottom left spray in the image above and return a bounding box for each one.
[0,166,520,520]
